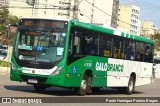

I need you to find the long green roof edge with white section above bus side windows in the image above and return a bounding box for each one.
[71,20,154,44]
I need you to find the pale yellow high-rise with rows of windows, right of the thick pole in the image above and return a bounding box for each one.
[118,4,140,35]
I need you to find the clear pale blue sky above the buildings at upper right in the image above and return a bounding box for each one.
[119,0,160,28]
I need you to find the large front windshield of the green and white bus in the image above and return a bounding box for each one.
[14,19,67,63]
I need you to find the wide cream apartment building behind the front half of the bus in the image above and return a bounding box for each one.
[9,0,119,26]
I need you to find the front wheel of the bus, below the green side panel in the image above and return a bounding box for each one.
[74,75,88,96]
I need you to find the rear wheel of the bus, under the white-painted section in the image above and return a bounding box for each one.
[126,76,135,95]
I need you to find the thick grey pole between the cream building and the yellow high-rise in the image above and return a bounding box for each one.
[111,0,119,28]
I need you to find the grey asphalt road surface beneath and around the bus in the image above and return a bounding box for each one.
[0,75,160,106]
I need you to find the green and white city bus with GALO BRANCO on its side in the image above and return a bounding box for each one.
[10,17,154,96]
